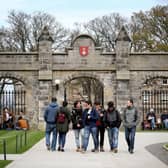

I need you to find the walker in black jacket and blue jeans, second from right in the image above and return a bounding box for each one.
[104,101,121,153]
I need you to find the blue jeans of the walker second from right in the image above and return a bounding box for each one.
[108,127,119,150]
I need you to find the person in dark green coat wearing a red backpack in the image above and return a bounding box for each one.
[56,101,71,152]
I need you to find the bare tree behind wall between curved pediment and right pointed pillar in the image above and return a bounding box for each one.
[84,13,126,50]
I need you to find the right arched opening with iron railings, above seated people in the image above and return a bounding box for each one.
[141,77,168,129]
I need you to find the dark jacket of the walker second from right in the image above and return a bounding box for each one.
[104,108,121,128]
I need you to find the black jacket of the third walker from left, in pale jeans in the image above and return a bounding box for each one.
[71,108,83,129]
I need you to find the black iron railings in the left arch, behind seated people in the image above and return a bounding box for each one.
[0,90,26,115]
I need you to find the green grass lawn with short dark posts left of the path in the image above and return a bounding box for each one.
[0,130,44,168]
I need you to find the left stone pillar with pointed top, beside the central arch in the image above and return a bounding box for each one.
[38,27,53,129]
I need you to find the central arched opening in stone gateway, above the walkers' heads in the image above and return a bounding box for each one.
[64,76,104,105]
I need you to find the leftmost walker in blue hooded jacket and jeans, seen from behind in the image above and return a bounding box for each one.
[44,97,59,151]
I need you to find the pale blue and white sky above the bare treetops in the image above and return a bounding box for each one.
[0,0,168,28]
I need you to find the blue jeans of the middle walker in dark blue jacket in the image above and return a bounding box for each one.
[83,126,98,151]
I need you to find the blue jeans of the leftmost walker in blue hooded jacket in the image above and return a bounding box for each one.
[45,124,57,151]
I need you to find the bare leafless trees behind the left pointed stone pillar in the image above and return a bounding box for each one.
[0,10,68,52]
